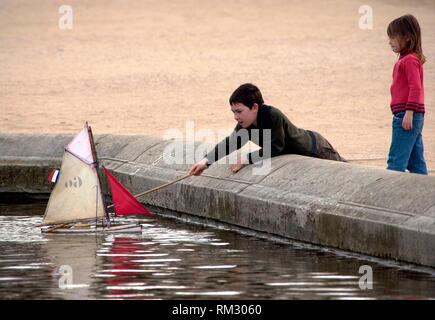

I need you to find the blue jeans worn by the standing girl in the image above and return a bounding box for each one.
[387,112,427,174]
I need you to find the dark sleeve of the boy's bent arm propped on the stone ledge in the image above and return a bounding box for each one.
[248,117,285,164]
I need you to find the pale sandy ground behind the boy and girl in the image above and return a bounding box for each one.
[0,0,435,175]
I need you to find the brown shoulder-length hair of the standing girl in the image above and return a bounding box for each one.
[387,14,426,64]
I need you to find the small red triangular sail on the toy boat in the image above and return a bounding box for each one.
[103,167,154,216]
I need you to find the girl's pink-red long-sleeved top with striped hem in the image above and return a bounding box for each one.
[390,53,425,114]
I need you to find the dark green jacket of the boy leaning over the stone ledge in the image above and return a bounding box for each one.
[206,104,315,164]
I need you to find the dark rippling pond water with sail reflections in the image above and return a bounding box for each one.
[0,197,435,300]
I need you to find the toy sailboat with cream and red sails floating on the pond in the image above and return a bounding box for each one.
[40,122,153,233]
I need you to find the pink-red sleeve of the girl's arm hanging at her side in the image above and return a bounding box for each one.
[404,59,423,111]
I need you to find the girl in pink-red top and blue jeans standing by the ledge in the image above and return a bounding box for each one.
[387,14,427,175]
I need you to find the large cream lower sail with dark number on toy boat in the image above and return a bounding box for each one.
[43,151,105,223]
